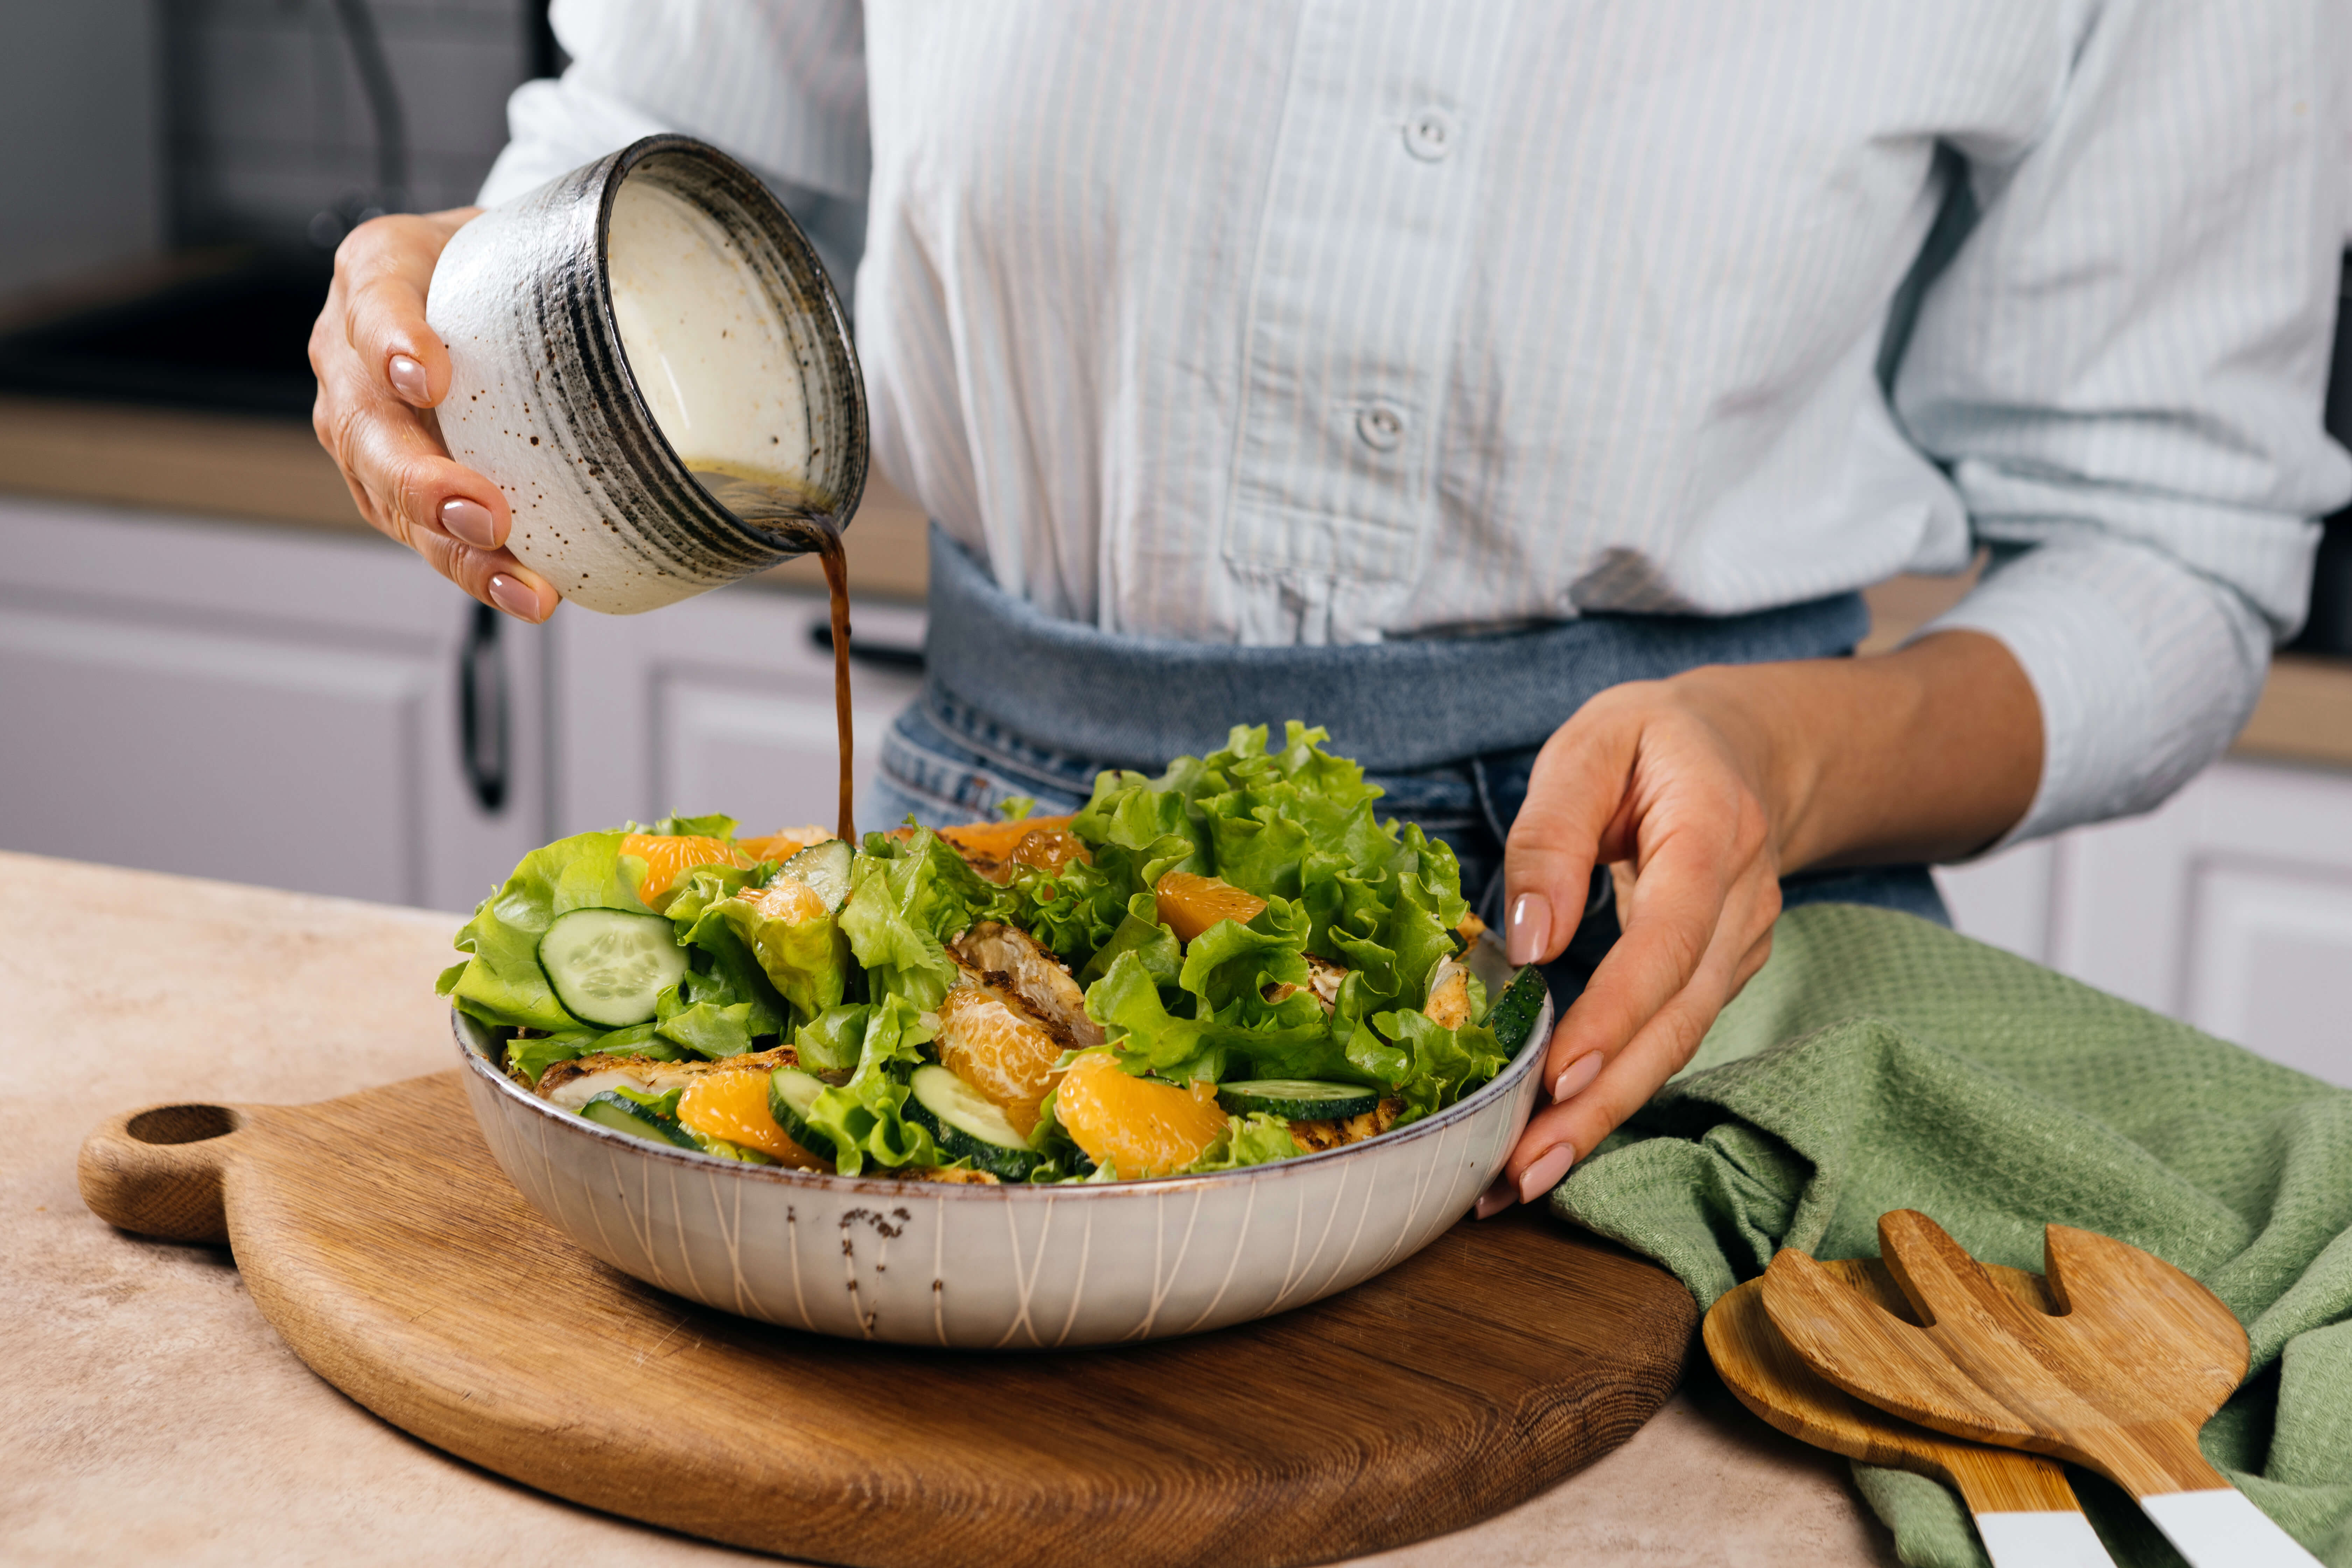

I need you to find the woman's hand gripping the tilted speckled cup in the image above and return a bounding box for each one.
[310,207,555,621]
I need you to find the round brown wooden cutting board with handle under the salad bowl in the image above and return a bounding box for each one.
[82,1072,1698,1568]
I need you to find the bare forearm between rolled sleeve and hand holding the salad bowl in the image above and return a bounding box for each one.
[1675,632,2042,872]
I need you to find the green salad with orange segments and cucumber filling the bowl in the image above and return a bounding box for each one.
[440,722,1543,1182]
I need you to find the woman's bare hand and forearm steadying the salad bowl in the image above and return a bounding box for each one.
[1479,632,2042,1216]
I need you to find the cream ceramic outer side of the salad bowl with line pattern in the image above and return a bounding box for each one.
[451,950,1552,1349]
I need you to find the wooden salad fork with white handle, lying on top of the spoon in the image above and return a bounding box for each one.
[1764,1208,2319,1568]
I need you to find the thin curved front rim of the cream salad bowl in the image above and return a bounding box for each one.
[449,959,1555,1201]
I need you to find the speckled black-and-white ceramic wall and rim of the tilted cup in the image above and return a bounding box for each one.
[426,136,868,616]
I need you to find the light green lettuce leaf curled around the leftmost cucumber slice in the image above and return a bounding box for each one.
[447,832,651,1034]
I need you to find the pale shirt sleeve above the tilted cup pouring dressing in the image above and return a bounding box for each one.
[477,0,870,299]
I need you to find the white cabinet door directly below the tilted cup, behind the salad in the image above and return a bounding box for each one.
[553,585,922,832]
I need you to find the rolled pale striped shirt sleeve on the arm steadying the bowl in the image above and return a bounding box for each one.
[1893,0,2352,842]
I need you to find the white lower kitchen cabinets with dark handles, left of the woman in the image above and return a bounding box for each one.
[0,498,922,910]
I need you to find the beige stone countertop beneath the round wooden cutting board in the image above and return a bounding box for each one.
[0,853,1893,1568]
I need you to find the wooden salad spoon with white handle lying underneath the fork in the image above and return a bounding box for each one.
[1703,1258,2114,1568]
